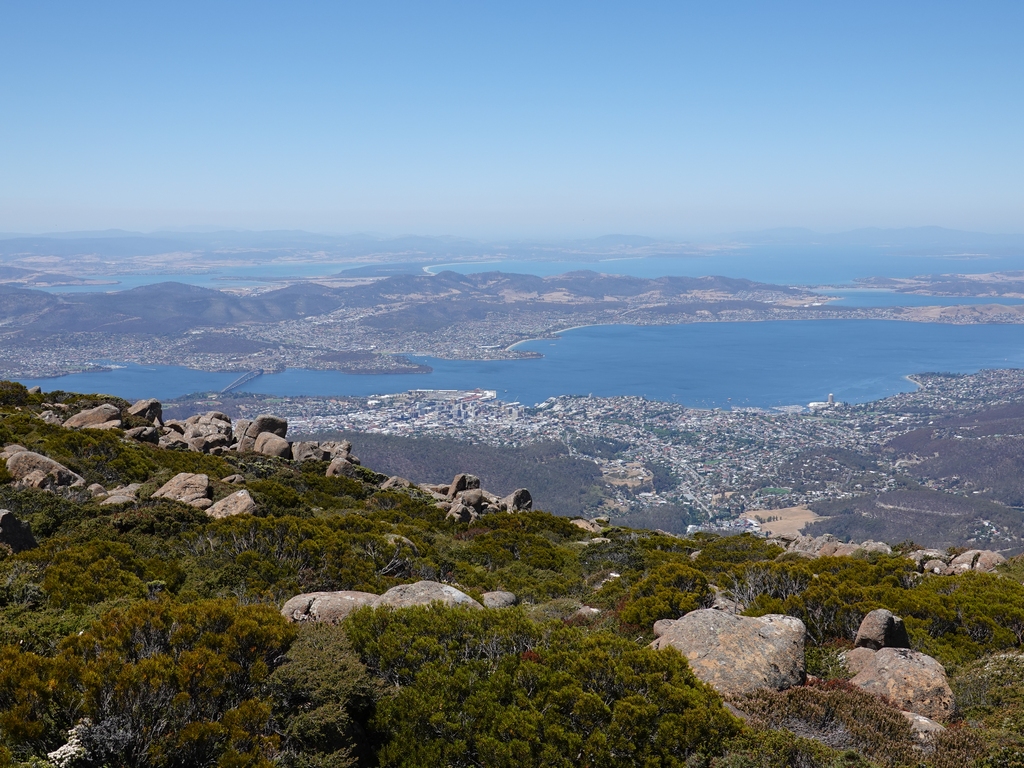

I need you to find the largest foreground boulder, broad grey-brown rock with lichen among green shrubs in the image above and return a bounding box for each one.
[650,608,807,694]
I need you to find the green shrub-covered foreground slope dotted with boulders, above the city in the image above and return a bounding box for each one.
[0,383,1024,768]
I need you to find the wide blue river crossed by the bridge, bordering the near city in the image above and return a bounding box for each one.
[23,321,1024,408]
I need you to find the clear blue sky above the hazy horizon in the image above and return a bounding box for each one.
[0,0,1024,238]
